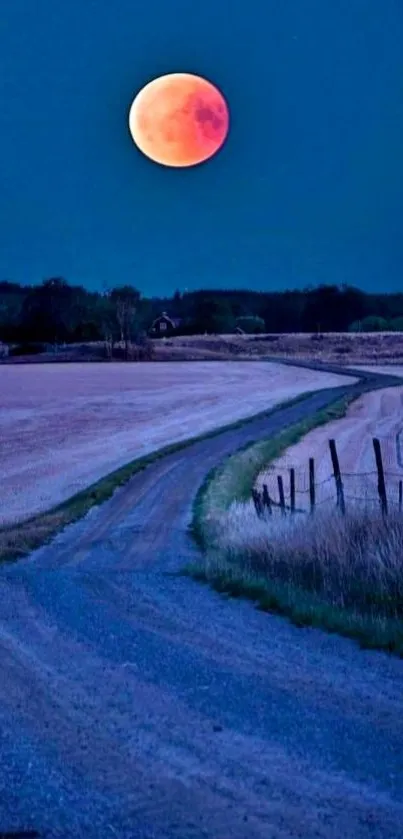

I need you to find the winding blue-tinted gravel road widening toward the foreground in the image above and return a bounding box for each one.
[0,367,403,839]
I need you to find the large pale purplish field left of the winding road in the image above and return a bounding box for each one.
[0,361,355,525]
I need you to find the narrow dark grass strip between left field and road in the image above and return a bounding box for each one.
[0,390,326,562]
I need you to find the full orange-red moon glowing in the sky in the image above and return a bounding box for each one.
[129,73,229,167]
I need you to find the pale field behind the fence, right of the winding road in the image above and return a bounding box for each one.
[256,382,403,510]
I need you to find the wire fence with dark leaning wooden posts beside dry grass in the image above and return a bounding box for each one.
[252,435,403,518]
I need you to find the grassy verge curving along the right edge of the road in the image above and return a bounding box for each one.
[184,394,403,657]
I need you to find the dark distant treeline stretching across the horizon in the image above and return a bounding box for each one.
[0,277,403,344]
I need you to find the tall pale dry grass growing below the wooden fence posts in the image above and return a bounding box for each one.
[208,502,403,618]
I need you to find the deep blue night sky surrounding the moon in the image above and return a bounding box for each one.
[0,0,403,295]
